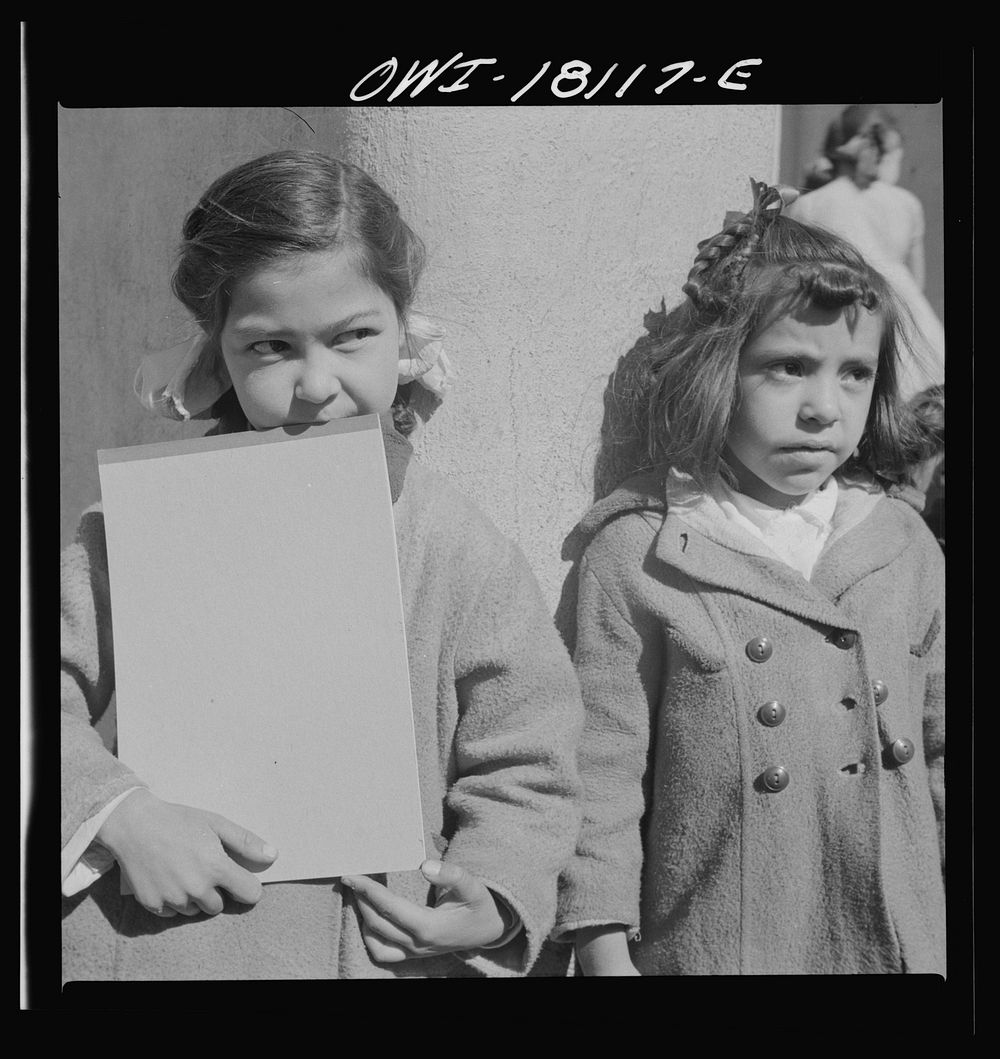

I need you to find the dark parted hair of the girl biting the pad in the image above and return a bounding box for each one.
[172,150,424,434]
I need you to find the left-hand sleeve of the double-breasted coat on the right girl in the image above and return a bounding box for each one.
[555,519,664,940]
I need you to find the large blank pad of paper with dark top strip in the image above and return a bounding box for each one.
[99,416,425,882]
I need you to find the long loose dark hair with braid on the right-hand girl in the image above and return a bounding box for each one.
[638,193,919,489]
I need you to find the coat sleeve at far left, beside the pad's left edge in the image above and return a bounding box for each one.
[60,507,143,846]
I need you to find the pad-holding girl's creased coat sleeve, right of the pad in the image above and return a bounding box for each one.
[436,542,583,974]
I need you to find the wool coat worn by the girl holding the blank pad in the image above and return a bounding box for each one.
[63,431,583,981]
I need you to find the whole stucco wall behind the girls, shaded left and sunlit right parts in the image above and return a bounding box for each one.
[59,106,780,608]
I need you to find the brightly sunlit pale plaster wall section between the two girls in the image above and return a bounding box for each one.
[346,106,780,608]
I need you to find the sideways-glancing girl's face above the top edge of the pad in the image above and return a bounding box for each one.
[220,250,399,430]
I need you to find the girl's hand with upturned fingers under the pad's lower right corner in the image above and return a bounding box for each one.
[341,861,506,964]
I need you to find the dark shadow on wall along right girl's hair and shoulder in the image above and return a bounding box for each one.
[555,302,684,654]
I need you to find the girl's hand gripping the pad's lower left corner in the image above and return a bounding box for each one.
[96,790,278,916]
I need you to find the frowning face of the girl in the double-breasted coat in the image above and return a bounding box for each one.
[727,306,882,507]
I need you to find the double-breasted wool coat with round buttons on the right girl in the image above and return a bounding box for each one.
[557,478,945,974]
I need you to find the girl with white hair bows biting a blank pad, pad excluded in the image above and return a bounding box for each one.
[63,151,582,981]
